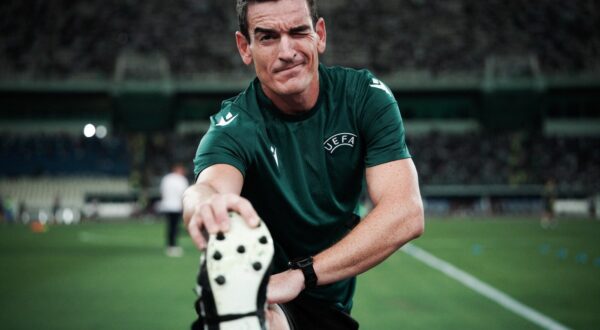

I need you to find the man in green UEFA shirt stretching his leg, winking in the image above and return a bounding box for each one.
[184,0,424,329]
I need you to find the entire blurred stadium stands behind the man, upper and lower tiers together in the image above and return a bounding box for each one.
[0,0,600,220]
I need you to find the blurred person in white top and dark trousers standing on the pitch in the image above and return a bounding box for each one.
[160,164,189,257]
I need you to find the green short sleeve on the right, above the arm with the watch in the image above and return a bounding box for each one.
[361,75,411,167]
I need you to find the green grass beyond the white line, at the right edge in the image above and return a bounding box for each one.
[400,219,600,329]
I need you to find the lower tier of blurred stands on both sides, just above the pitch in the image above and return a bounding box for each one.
[0,127,600,218]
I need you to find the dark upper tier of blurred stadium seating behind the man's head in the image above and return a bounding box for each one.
[0,0,600,79]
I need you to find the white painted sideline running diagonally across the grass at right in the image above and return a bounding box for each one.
[402,243,569,330]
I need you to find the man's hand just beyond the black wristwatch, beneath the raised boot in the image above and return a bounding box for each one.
[267,269,304,304]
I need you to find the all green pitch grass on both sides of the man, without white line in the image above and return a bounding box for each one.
[0,219,600,330]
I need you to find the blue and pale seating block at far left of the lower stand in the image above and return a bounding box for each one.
[0,130,132,220]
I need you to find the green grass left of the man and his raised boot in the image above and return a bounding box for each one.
[0,222,198,329]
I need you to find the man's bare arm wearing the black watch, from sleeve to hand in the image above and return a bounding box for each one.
[267,159,424,303]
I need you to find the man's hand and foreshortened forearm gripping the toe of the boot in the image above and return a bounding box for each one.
[183,164,259,249]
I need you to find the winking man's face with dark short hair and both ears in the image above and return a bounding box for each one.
[236,0,326,97]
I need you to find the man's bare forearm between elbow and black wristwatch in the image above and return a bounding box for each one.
[314,198,424,285]
